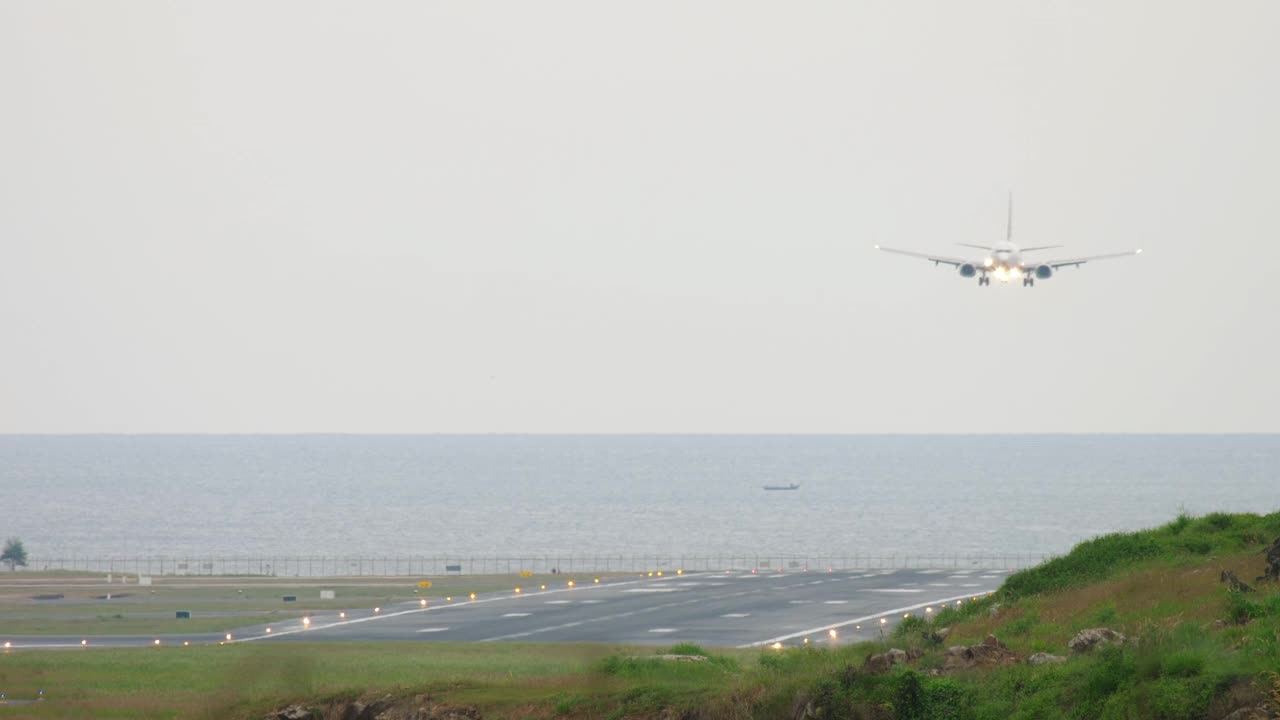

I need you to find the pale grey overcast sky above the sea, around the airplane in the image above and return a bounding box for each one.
[0,0,1280,433]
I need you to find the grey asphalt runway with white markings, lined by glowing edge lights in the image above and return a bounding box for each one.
[0,570,1006,650]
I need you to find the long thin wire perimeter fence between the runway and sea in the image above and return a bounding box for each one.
[28,553,1051,578]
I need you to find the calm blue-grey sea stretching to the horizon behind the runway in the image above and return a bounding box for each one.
[0,434,1280,557]
